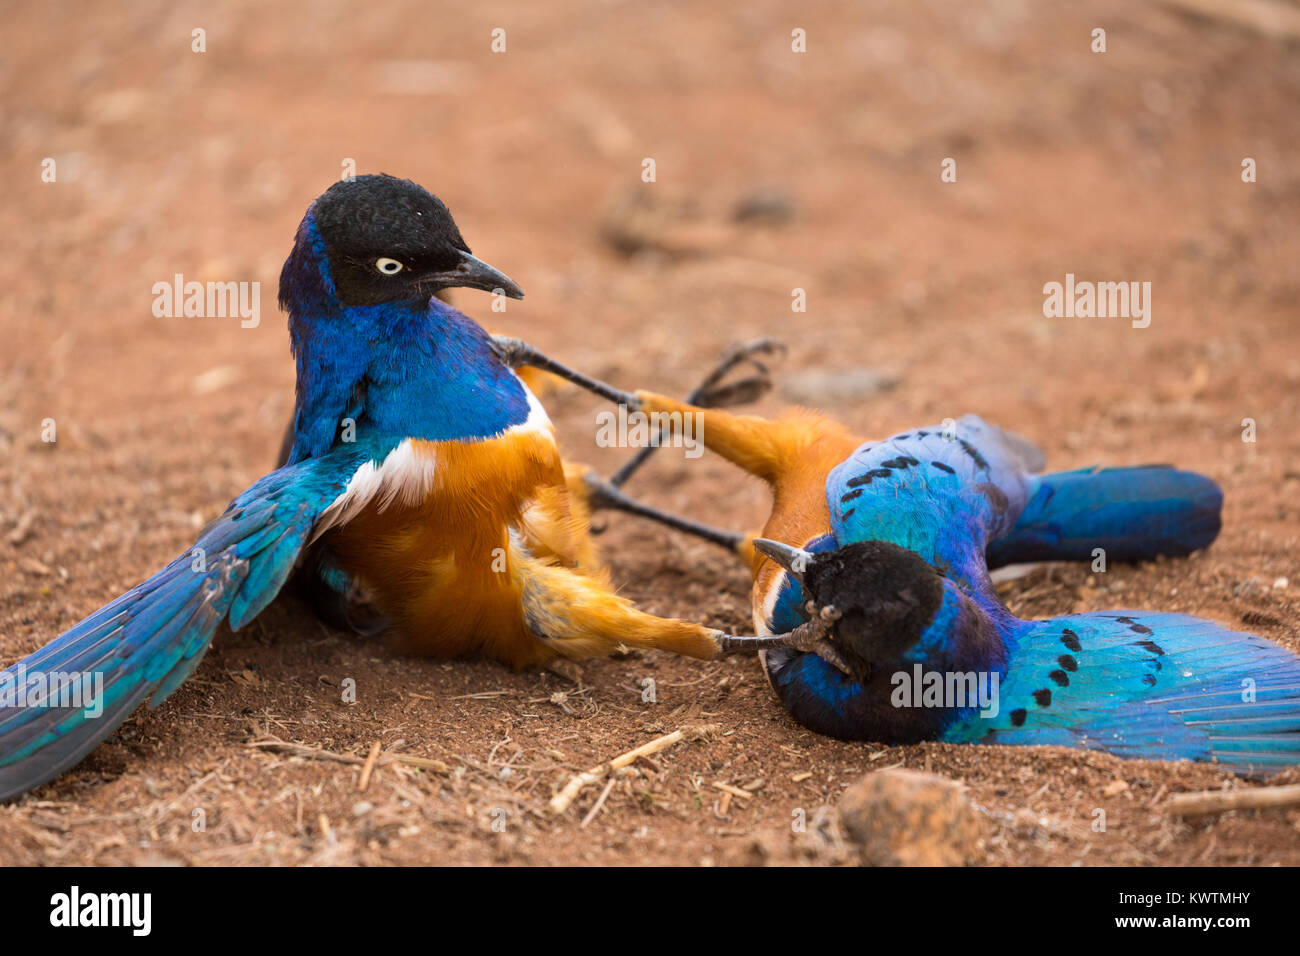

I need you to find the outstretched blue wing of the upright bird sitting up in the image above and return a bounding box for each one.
[0,444,371,800]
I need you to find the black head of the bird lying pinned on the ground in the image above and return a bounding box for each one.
[754,538,944,676]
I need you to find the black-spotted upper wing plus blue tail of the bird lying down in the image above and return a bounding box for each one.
[827,415,1223,574]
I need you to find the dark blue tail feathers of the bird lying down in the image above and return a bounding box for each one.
[988,466,1223,567]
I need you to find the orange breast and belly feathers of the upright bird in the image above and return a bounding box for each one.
[329,406,595,666]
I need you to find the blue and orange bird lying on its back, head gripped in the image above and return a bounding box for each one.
[608,392,1300,773]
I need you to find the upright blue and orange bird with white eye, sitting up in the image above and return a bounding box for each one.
[0,176,790,799]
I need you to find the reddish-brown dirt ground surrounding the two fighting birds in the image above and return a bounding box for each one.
[0,0,1300,865]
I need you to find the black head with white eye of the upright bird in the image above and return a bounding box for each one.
[306,176,524,306]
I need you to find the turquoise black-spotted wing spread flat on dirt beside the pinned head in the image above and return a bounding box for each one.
[941,611,1300,773]
